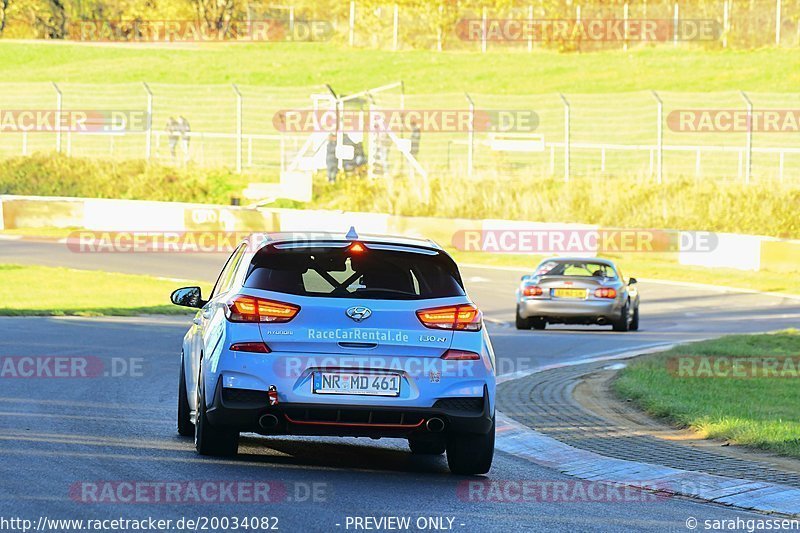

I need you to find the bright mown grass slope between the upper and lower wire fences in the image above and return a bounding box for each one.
[0,40,800,94]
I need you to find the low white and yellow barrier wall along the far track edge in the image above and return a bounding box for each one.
[0,195,800,273]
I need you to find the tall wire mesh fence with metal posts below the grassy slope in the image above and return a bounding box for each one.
[0,83,800,182]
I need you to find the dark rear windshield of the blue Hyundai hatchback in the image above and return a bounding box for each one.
[244,245,464,300]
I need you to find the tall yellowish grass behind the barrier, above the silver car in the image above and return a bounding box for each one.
[308,178,800,238]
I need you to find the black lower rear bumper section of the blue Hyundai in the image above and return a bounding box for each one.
[207,383,493,438]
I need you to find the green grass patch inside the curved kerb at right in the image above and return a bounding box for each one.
[614,330,800,457]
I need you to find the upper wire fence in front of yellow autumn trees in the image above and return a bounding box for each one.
[249,0,800,51]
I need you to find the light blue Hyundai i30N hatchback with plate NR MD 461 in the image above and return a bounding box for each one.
[171,229,495,474]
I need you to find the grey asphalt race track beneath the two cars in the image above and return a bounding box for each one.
[0,241,800,531]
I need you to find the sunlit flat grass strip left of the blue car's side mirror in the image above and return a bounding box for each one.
[0,264,210,316]
